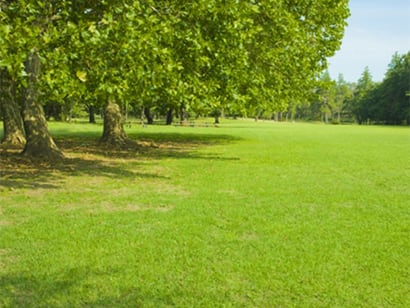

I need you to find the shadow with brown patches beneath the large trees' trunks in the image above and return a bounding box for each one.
[0,133,239,189]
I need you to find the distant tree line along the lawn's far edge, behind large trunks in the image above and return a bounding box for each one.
[34,53,410,125]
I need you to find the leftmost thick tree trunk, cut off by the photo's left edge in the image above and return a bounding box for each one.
[0,70,26,145]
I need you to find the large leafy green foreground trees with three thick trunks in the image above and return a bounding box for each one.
[0,0,349,159]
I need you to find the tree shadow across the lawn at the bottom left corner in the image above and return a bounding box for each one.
[0,266,181,307]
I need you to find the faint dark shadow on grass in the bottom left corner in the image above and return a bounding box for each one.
[0,266,181,307]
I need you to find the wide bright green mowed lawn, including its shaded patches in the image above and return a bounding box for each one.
[0,120,410,307]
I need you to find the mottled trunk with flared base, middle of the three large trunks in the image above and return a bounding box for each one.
[22,52,63,160]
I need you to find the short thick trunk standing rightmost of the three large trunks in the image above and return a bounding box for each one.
[101,102,127,146]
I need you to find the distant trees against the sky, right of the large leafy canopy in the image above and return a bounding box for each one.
[295,52,410,125]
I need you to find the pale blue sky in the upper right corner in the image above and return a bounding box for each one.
[329,0,410,82]
